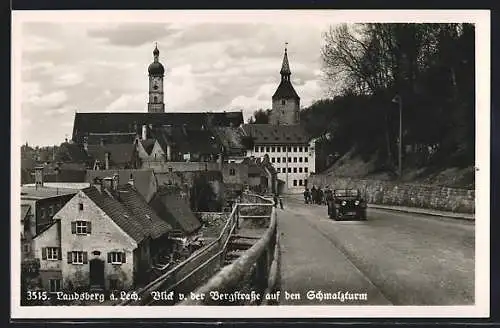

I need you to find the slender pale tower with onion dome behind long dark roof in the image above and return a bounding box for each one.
[148,45,165,113]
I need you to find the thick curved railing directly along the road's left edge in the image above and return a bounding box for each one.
[179,195,280,305]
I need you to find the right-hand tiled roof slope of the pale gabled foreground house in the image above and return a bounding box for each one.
[82,186,171,243]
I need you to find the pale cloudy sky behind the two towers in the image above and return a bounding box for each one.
[15,12,336,145]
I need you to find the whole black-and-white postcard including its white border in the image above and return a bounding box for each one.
[11,10,490,319]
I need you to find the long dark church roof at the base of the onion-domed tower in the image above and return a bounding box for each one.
[73,112,243,143]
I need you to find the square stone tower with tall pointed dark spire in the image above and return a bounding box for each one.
[269,47,300,125]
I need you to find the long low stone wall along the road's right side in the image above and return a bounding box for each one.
[309,175,475,213]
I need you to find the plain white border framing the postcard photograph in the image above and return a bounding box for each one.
[10,10,490,319]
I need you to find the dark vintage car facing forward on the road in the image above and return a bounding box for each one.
[327,189,366,221]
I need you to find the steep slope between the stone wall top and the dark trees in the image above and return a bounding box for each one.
[319,150,474,189]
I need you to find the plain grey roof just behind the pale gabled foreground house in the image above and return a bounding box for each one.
[85,169,156,201]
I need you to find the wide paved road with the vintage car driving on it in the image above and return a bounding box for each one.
[278,197,474,305]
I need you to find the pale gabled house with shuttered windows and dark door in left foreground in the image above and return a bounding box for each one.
[33,176,172,291]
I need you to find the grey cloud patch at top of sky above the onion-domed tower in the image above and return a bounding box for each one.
[87,23,177,47]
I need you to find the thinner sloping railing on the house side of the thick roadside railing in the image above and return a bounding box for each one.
[117,193,272,305]
